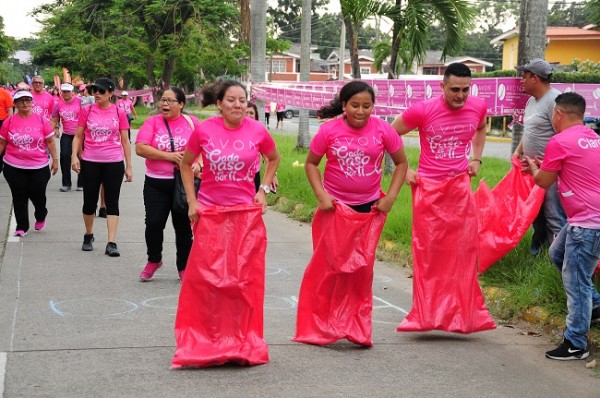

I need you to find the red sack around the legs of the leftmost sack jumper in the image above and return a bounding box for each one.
[172,204,269,368]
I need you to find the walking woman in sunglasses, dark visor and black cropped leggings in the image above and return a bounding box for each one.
[71,77,133,257]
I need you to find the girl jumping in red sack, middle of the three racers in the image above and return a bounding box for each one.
[293,81,408,347]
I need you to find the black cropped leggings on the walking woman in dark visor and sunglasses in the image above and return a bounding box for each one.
[80,159,125,216]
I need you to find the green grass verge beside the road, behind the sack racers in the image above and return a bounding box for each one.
[268,134,600,320]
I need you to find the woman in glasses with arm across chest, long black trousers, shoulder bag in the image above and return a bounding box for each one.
[135,87,200,282]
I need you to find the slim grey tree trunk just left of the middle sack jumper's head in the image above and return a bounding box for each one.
[296,0,312,149]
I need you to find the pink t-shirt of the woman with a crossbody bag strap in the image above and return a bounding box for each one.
[135,115,200,178]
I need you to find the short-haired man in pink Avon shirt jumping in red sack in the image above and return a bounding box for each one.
[392,63,496,333]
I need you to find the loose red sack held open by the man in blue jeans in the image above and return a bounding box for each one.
[474,158,546,274]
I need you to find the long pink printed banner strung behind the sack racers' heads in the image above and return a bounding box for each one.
[251,76,600,118]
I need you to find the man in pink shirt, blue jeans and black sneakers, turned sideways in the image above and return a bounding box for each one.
[526,93,600,361]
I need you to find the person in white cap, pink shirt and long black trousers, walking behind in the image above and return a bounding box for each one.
[52,83,83,192]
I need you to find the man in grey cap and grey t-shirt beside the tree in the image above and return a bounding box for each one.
[513,58,567,256]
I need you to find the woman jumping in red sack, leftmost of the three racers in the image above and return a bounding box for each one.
[172,80,279,368]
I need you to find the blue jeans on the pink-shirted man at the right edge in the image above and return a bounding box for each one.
[550,223,600,349]
